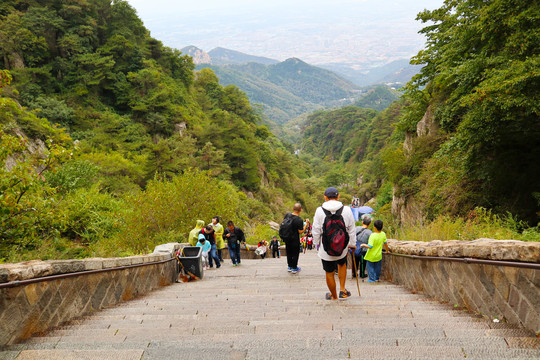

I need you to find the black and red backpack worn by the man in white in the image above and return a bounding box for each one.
[322,206,349,256]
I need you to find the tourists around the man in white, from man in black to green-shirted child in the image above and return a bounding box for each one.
[280,187,390,300]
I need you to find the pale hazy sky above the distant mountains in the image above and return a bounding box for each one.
[128,0,443,66]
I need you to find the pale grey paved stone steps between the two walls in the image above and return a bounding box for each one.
[0,251,540,360]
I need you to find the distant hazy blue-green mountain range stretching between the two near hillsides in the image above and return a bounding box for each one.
[181,46,408,124]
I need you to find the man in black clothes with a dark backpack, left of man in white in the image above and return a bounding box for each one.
[279,203,309,274]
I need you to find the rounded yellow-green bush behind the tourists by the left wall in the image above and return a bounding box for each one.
[112,170,239,254]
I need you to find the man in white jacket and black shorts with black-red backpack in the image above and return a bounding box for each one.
[312,187,356,300]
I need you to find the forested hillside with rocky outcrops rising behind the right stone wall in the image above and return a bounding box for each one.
[298,0,540,239]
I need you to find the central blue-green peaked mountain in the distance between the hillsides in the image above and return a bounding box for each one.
[200,58,360,124]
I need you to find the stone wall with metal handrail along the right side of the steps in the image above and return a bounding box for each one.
[383,239,540,333]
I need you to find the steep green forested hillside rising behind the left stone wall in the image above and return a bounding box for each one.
[0,0,320,261]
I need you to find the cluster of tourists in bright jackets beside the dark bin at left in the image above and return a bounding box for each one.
[188,216,246,270]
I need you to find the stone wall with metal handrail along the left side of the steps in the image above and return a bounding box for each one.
[0,244,181,346]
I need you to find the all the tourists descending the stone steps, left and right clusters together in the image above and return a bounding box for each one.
[189,187,390,300]
